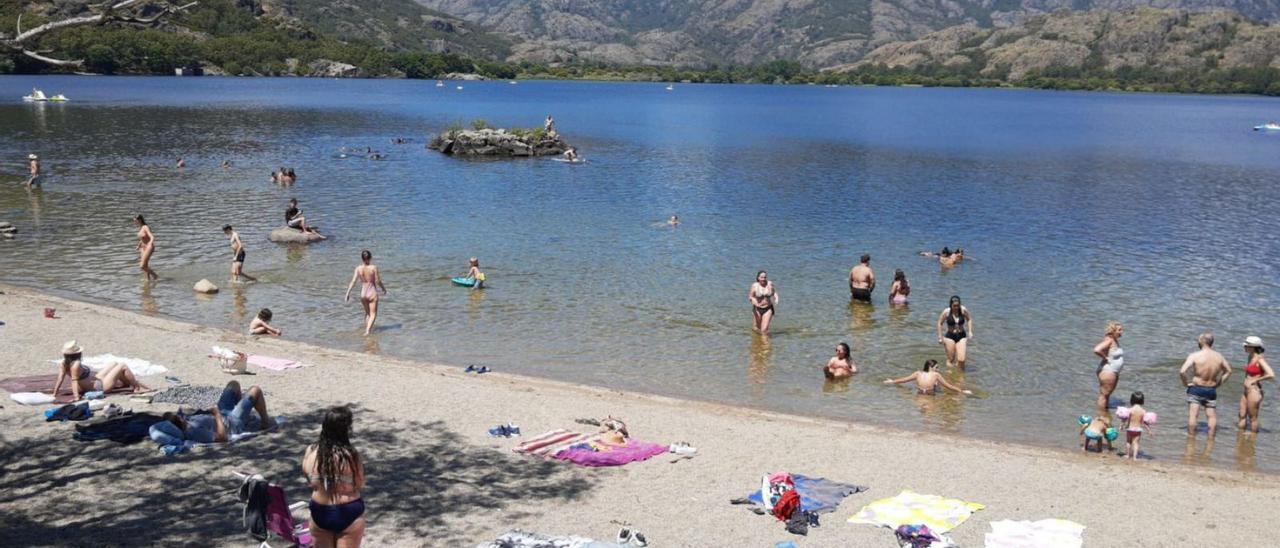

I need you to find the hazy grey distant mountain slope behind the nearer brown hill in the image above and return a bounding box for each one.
[417,0,1280,68]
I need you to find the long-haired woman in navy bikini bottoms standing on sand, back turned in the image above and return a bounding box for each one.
[302,406,365,548]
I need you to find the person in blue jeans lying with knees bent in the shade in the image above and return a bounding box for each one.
[151,380,274,446]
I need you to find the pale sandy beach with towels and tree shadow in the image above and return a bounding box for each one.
[0,282,1280,547]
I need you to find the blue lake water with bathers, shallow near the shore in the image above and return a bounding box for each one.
[0,77,1280,471]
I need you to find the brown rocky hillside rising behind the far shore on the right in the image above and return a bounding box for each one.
[837,8,1280,81]
